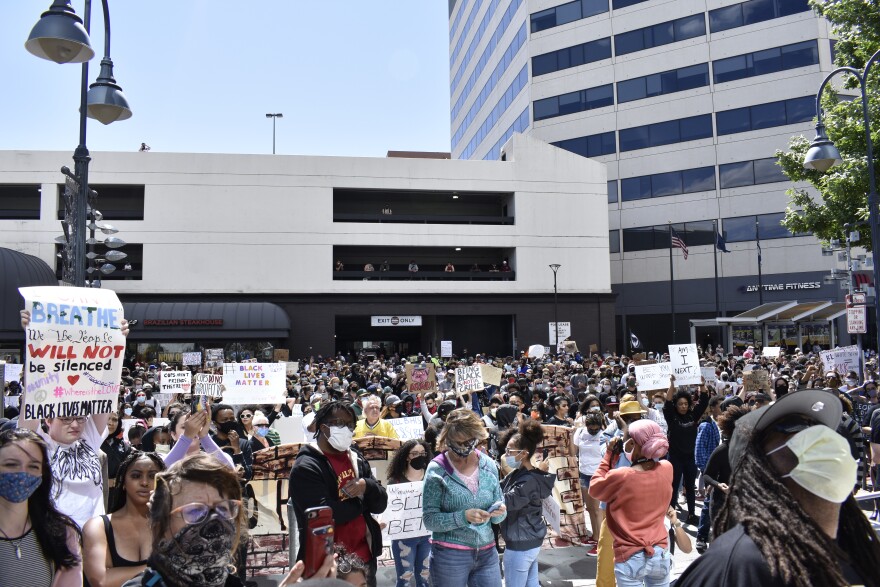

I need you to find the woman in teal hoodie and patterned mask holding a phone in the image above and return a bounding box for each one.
[422,408,507,587]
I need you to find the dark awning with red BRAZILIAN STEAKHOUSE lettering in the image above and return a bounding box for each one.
[123,302,290,342]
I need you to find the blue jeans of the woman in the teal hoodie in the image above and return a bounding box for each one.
[430,544,501,587]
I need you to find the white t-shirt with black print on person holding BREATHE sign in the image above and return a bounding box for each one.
[37,417,106,528]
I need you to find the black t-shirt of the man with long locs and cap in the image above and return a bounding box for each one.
[674,526,864,587]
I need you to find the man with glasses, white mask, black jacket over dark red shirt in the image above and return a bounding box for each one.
[290,401,388,587]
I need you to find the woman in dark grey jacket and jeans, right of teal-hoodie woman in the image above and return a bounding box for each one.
[501,420,556,587]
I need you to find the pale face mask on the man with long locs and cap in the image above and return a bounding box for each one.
[767,424,858,503]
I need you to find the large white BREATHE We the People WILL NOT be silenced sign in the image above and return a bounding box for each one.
[18,286,125,420]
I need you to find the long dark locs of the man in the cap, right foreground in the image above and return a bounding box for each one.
[714,430,880,587]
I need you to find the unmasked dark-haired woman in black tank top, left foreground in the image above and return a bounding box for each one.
[83,451,165,587]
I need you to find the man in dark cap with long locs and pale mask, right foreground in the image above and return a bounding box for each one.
[676,390,880,587]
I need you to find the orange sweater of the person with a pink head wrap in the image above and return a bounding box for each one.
[590,452,672,563]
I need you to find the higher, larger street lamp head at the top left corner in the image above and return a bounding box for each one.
[24,0,95,63]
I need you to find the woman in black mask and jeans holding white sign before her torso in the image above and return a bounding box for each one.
[388,440,434,587]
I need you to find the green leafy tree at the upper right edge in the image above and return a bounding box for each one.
[776,0,880,247]
